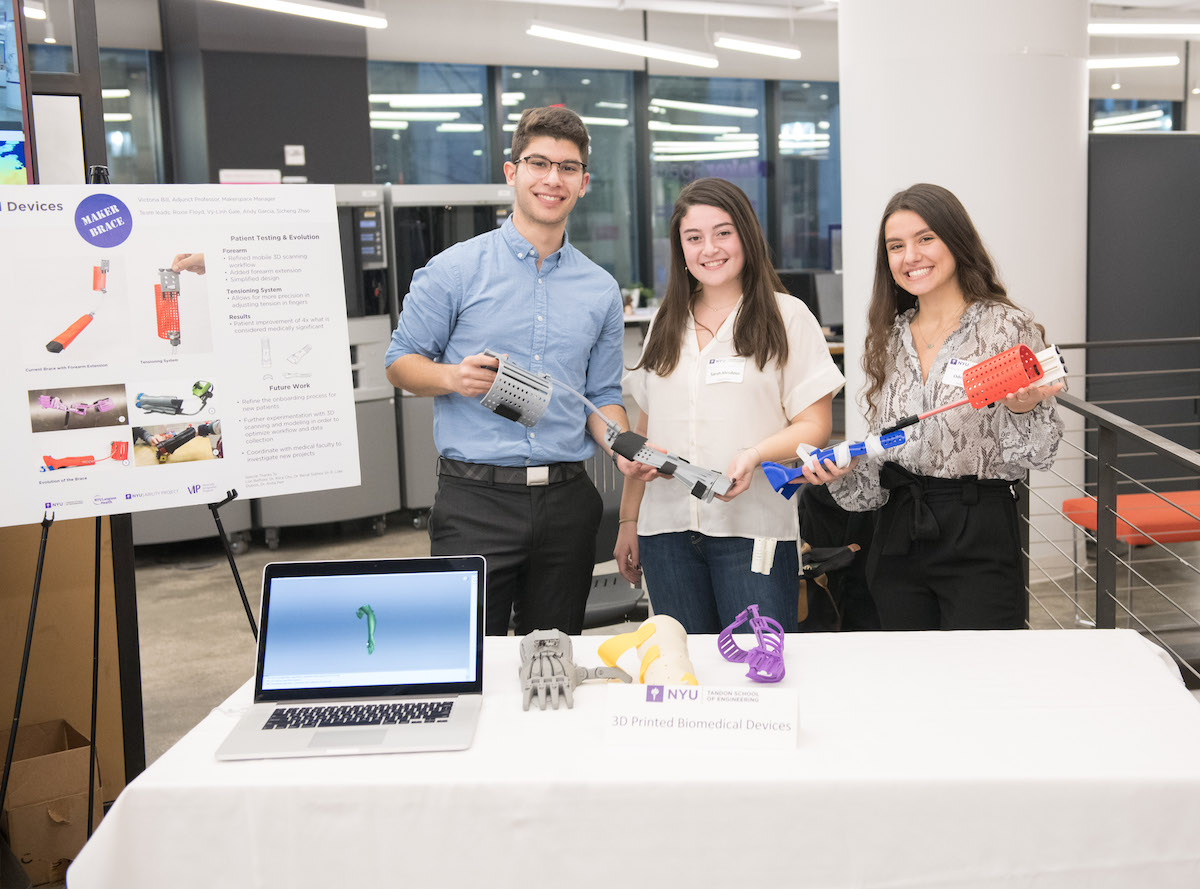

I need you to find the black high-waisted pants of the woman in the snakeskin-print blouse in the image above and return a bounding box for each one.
[866,462,1028,630]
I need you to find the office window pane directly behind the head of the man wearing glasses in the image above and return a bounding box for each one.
[500,67,640,287]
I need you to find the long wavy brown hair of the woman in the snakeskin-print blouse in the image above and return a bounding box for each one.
[862,182,1045,421]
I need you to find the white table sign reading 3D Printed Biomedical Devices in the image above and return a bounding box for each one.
[604,685,799,750]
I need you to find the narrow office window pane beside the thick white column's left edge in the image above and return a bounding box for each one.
[776,80,841,269]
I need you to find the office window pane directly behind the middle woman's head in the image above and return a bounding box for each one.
[649,77,767,294]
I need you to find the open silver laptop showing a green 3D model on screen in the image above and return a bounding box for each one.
[216,555,485,759]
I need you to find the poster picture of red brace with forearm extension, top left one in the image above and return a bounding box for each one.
[35,253,126,366]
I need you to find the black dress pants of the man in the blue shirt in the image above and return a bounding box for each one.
[430,473,604,636]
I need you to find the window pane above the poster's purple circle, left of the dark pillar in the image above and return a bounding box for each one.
[100,49,164,184]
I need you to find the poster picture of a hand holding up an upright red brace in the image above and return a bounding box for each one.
[141,251,212,358]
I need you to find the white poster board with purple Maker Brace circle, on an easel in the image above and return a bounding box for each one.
[0,185,360,525]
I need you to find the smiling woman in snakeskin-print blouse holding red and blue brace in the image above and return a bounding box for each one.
[808,184,1062,630]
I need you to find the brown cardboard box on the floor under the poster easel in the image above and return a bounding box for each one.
[0,720,103,885]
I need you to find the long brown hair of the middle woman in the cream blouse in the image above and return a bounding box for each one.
[635,179,787,377]
